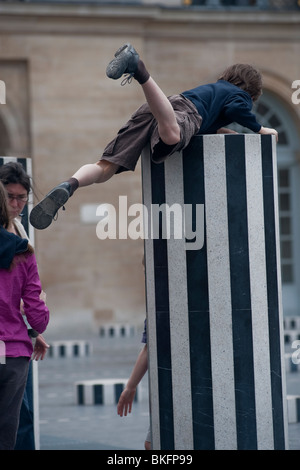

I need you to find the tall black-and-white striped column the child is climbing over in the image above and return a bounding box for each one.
[142,134,287,450]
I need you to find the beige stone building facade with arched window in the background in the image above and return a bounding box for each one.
[0,1,300,334]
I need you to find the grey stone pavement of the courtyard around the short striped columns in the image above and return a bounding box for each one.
[38,333,300,451]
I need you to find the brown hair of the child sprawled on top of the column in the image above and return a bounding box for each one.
[219,64,262,101]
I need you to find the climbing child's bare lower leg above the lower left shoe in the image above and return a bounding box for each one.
[72,160,119,188]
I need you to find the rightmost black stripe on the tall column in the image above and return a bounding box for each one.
[261,136,285,450]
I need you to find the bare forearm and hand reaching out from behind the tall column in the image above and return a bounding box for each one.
[117,344,148,416]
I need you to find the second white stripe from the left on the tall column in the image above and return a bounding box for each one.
[165,153,193,450]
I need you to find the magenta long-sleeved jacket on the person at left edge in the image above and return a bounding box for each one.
[0,253,49,360]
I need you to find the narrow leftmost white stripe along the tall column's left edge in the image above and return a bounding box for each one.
[142,147,160,450]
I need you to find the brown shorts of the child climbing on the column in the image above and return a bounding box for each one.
[100,95,202,173]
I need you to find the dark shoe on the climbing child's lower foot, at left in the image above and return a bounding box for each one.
[29,188,70,230]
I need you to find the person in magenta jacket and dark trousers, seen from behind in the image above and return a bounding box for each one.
[0,183,49,450]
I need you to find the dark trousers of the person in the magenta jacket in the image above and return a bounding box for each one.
[0,357,29,450]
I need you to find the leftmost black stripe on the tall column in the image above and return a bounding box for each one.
[149,162,174,450]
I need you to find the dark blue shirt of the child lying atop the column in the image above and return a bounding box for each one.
[182,80,261,134]
